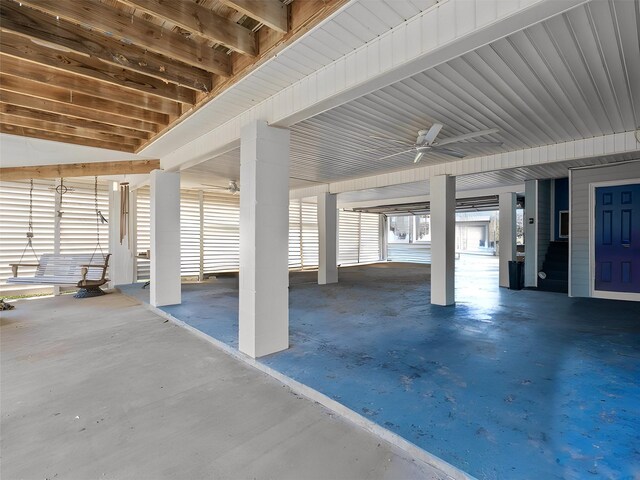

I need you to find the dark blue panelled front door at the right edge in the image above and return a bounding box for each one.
[595,184,640,293]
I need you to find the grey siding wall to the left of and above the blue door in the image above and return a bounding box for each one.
[569,161,640,297]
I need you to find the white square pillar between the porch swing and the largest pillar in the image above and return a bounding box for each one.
[150,170,182,307]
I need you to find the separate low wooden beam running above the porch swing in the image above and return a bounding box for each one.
[0,160,160,181]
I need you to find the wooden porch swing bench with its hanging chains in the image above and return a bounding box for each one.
[7,177,111,298]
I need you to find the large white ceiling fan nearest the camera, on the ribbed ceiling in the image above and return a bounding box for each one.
[363,123,502,163]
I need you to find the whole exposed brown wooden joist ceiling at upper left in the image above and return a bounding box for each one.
[0,0,347,152]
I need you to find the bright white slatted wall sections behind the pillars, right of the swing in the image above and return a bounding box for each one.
[136,195,380,280]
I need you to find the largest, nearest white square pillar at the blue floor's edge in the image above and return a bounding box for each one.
[239,121,290,358]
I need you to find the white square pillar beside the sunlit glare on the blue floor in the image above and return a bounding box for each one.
[431,175,456,306]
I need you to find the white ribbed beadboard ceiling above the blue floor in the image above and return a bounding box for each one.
[184,0,640,201]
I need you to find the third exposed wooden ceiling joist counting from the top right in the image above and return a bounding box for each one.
[16,0,230,76]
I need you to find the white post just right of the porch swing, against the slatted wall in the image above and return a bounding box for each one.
[109,182,135,287]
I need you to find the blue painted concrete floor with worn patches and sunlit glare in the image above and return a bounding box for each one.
[121,256,640,479]
